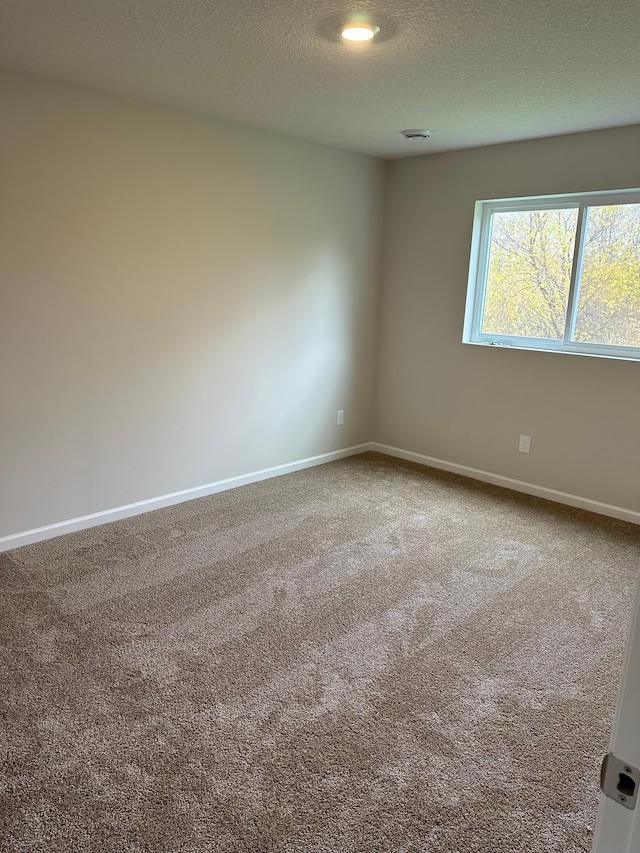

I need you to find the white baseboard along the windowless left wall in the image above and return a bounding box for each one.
[0,442,371,553]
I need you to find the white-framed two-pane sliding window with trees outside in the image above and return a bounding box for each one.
[463,190,640,360]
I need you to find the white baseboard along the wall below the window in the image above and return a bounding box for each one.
[371,441,640,524]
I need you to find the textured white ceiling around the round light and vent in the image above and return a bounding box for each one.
[0,0,640,157]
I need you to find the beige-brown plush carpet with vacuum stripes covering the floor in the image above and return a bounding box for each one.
[0,454,640,853]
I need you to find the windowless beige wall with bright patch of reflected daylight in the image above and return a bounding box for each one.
[0,75,382,536]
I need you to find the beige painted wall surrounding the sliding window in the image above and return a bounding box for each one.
[375,126,640,511]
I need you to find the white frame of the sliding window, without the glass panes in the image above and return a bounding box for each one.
[462,189,640,361]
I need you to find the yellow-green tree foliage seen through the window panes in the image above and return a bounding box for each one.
[481,204,640,347]
